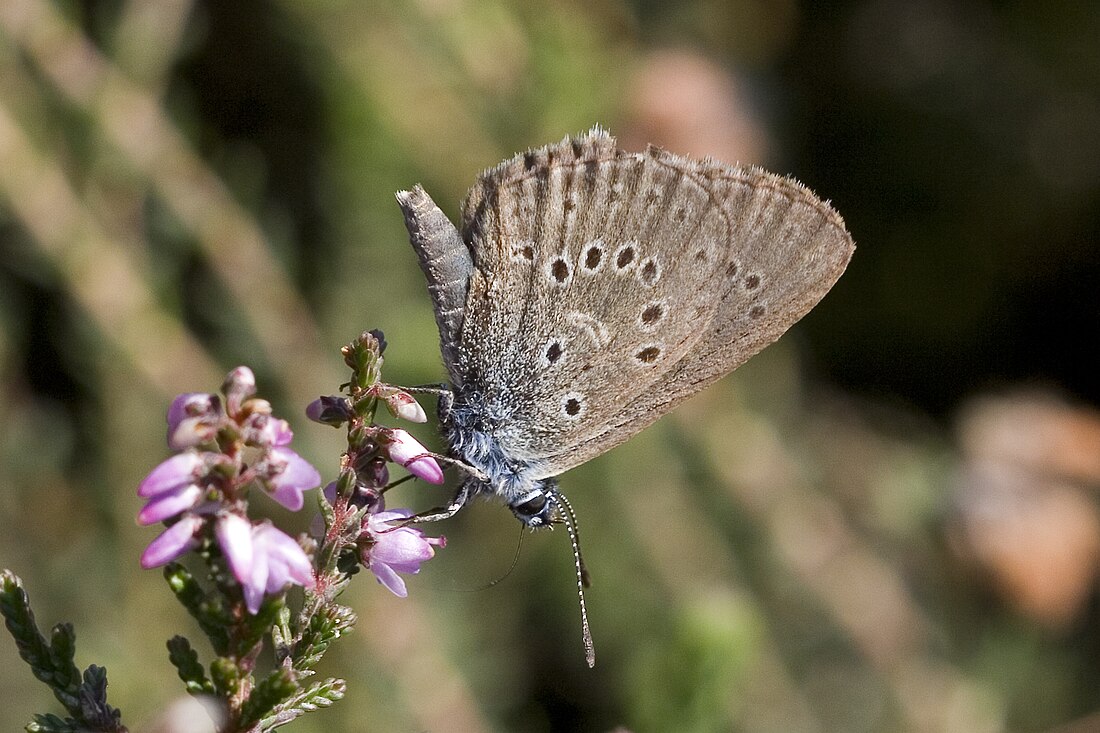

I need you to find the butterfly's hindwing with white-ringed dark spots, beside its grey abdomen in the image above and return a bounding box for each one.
[462,128,730,459]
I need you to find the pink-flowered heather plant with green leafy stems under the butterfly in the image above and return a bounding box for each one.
[0,331,444,733]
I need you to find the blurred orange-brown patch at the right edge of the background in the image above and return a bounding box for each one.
[957,394,1100,628]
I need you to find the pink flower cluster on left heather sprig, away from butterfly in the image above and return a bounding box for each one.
[138,367,321,614]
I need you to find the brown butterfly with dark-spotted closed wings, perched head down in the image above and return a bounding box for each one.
[397,127,855,664]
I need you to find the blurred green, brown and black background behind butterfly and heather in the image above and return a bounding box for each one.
[0,0,1100,733]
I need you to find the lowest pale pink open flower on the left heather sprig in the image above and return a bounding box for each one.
[215,514,315,614]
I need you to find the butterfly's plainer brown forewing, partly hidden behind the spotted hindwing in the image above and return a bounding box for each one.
[528,151,855,472]
